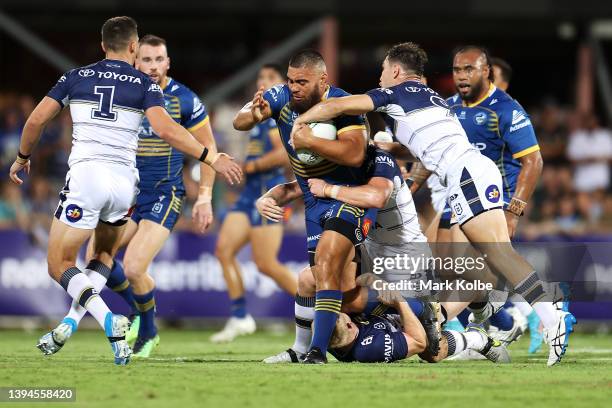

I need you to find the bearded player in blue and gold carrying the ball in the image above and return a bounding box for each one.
[234,50,367,364]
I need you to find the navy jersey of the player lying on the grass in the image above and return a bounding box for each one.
[330,315,408,363]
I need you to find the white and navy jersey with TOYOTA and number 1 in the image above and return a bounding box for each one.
[47,59,164,167]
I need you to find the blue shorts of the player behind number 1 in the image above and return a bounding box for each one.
[132,189,185,231]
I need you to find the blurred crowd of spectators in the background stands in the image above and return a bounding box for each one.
[0,87,612,246]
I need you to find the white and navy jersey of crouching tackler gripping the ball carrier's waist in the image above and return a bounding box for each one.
[367,147,427,245]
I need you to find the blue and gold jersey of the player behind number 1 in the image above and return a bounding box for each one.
[136,78,209,191]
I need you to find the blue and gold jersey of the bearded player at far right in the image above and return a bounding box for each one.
[448,84,540,204]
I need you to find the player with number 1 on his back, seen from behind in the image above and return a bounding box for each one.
[10,17,241,364]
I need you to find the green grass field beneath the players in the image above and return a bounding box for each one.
[0,330,612,408]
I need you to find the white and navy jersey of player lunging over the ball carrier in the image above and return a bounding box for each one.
[367,81,476,180]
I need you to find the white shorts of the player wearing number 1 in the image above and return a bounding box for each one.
[55,161,139,229]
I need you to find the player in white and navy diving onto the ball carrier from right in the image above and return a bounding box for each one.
[292,43,574,366]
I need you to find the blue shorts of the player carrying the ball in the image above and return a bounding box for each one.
[306,199,376,263]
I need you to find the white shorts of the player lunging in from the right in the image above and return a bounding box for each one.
[446,152,504,225]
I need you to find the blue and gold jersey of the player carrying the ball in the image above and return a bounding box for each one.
[263,85,366,208]
